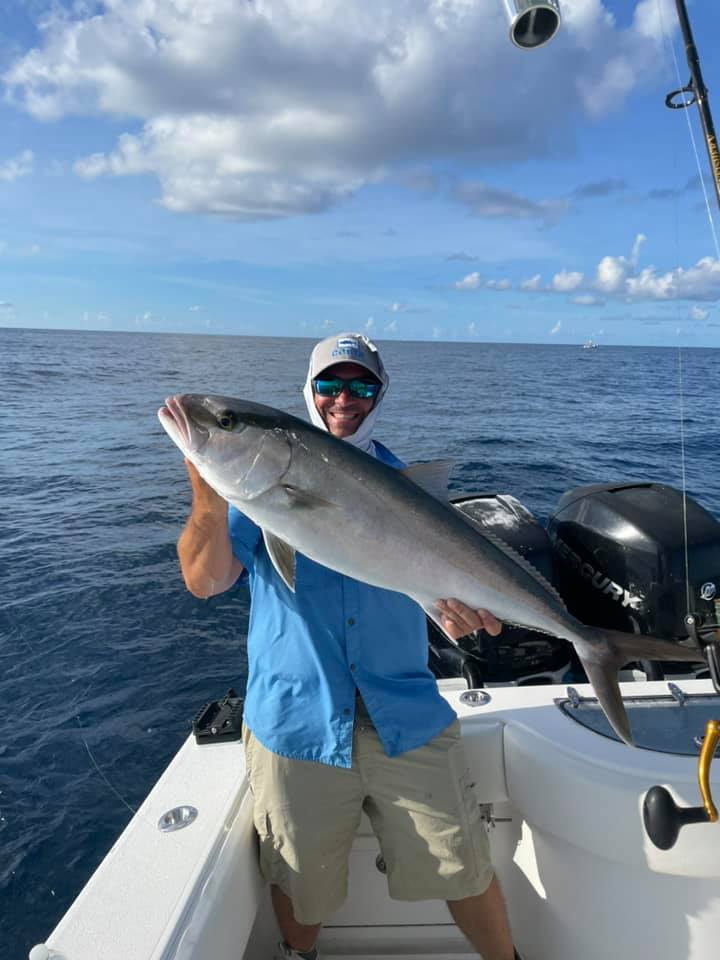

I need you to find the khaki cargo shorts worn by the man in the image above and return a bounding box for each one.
[243,701,493,924]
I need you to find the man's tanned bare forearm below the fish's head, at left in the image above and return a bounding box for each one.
[177,507,238,599]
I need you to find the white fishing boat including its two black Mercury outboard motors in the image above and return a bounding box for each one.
[31,483,720,960]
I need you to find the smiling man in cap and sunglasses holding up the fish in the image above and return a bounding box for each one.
[178,333,514,960]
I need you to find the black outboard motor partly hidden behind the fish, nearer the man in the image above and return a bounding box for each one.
[428,494,572,687]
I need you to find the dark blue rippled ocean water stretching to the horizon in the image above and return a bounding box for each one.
[0,329,720,960]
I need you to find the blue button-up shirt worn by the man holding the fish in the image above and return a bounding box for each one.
[228,444,455,767]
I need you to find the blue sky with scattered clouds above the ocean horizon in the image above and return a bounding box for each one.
[0,0,720,347]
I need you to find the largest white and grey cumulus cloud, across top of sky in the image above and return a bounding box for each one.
[2,0,673,221]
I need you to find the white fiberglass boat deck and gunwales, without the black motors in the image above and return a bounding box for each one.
[30,679,720,960]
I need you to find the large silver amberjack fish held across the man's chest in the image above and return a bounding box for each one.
[158,394,703,743]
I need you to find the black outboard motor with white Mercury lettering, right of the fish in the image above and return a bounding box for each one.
[548,483,720,685]
